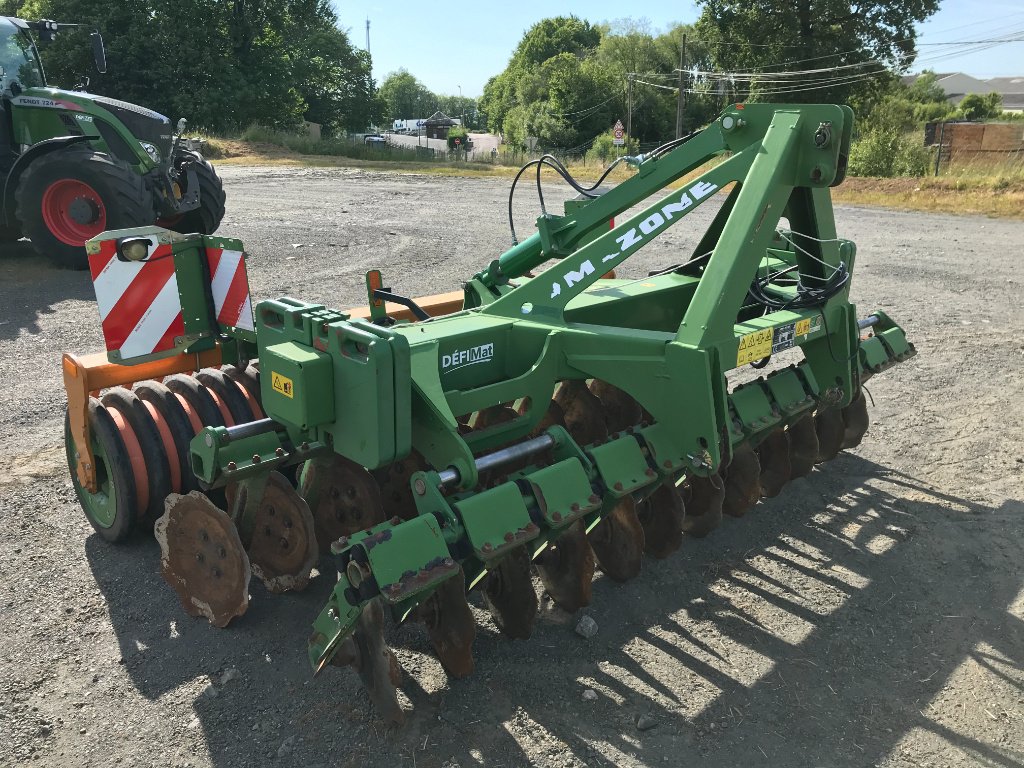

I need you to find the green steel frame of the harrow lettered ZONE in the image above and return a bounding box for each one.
[101,104,914,669]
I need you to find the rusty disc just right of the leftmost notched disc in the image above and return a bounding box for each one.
[247,472,319,592]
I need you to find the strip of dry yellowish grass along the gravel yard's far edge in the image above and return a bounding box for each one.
[204,126,1024,219]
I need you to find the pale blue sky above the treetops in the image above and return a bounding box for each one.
[333,0,1024,97]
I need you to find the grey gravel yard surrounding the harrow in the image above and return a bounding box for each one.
[0,168,1024,768]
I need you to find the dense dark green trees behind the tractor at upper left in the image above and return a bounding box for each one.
[9,0,379,132]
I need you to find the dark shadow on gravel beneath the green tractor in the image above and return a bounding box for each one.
[0,240,95,339]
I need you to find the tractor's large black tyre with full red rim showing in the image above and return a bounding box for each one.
[14,145,156,269]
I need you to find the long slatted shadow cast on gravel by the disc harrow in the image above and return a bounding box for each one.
[86,455,1024,768]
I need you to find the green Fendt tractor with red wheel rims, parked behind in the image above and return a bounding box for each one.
[0,16,224,269]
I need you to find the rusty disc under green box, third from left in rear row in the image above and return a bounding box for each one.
[299,454,385,555]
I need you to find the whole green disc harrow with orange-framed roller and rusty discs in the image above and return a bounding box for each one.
[65,104,914,722]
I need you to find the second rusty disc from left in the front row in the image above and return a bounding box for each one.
[417,568,476,678]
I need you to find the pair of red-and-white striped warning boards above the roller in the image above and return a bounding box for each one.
[89,236,254,362]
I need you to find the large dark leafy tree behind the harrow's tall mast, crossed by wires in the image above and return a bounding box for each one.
[696,0,939,103]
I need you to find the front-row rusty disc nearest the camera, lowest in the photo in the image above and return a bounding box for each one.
[331,598,406,725]
